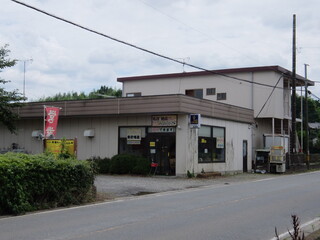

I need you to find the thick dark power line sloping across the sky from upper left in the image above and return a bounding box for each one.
[11,0,283,89]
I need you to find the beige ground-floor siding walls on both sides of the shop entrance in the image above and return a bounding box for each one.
[0,114,251,175]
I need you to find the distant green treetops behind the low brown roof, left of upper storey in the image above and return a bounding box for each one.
[39,86,122,102]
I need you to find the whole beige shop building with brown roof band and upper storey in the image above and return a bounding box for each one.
[0,66,313,175]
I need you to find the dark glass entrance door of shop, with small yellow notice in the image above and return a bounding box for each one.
[148,133,176,175]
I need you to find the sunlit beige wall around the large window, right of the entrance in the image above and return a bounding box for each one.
[176,115,252,175]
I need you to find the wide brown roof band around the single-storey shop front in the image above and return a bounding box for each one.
[17,94,254,123]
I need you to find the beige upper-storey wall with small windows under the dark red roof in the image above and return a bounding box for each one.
[123,71,290,119]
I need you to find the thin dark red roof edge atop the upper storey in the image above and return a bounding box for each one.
[117,65,314,86]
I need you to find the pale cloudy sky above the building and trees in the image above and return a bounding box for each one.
[0,0,320,101]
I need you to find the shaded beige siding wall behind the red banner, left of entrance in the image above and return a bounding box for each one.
[0,116,151,160]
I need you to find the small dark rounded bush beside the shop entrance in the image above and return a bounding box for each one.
[110,154,150,175]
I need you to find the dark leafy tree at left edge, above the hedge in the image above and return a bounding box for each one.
[0,44,25,133]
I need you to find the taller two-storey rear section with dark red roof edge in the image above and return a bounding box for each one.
[118,66,314,160]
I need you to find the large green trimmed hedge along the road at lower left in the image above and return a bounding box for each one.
[0,153,94,214]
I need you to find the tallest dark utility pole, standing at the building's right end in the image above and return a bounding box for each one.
[290,14,297,154]
